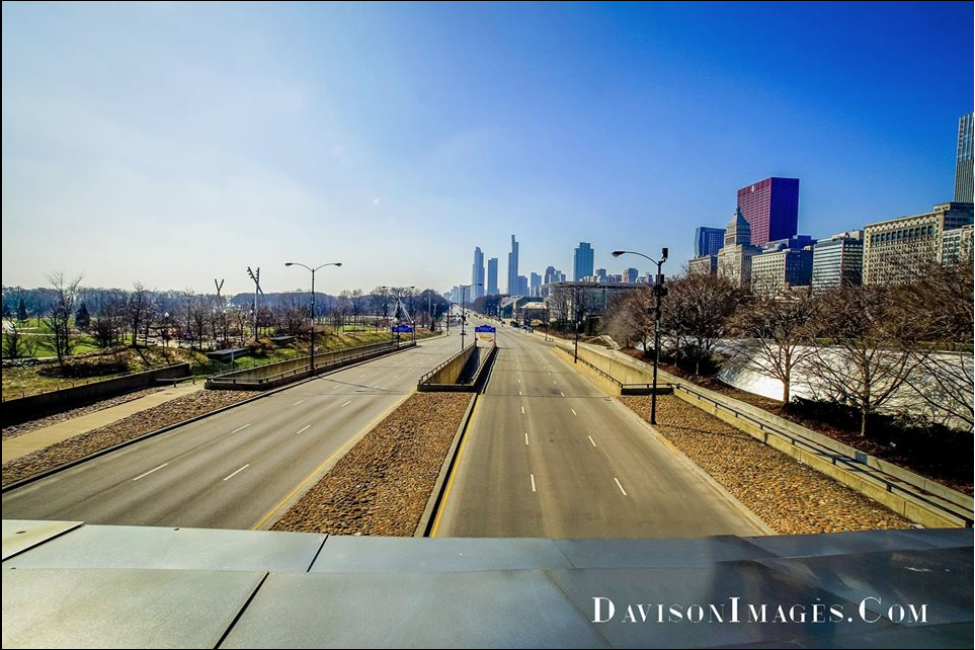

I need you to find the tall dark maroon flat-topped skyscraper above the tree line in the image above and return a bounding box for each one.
[738,177,799,246]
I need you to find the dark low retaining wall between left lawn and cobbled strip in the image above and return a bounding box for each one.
[3,363,190,427]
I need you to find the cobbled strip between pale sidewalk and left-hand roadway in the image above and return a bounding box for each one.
[3,390,261,486]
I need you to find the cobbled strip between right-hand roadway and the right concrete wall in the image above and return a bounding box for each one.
[619,395,913,535]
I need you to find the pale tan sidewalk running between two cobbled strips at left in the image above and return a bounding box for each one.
[3,382,203,465]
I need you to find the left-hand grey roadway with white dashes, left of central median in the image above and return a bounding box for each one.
[3,332,460,529]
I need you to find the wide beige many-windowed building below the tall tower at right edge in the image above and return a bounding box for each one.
[863,203,972,284]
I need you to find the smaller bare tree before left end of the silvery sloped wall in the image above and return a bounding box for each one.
[732,288,823,404]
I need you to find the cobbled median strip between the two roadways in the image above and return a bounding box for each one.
[272,393,473,537]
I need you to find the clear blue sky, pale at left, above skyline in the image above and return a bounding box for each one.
[2,2,973,291]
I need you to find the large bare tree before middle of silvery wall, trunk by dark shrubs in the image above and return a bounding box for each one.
[804,285,930,437]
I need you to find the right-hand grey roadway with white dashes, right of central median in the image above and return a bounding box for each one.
[434,320,763,539]
